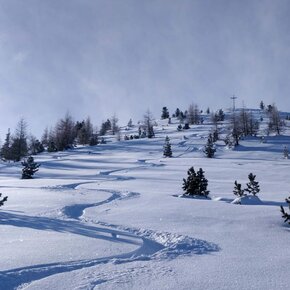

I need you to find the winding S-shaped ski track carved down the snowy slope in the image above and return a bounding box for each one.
[0,167,220,290]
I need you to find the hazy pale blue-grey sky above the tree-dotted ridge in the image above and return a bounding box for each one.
[0,0,290,141]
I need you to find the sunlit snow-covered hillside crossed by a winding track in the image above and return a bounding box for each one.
[0,111,290,290]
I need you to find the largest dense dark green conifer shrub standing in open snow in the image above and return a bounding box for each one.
[182,167,209,197]
